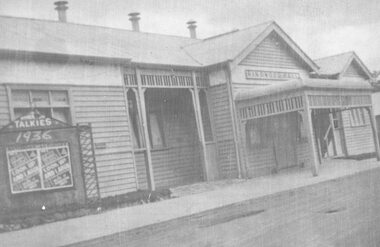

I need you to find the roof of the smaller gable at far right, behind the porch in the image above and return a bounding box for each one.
[314,51,371,78]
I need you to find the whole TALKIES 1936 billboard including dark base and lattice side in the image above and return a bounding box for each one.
[0,109,99,210]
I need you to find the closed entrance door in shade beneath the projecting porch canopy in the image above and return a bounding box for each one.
[272,112,297,169]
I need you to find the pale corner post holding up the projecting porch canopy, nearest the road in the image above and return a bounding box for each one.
[303,93,319,176]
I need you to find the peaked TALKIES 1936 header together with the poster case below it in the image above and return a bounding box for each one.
[1,110,74,194]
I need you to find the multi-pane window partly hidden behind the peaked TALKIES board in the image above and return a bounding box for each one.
[11,89,71,123]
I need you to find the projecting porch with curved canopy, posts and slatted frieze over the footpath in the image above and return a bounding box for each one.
[236,79,380,177]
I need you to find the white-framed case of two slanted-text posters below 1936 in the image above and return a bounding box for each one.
[6,143,73,194]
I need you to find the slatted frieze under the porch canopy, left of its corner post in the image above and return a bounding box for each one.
[240,96,303,120]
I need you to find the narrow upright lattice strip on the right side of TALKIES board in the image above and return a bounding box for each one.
[77,124,100,203]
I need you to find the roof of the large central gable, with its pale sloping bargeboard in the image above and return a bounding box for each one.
[184,21,318,71]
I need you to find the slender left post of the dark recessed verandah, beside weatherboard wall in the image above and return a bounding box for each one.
[135,68,156,190]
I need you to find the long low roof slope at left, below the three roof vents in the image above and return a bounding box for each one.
[0,16,199,66]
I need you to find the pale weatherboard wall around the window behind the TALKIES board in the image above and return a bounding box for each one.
[0,57,137,197]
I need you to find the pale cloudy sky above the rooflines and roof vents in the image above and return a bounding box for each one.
[0,0,380,70]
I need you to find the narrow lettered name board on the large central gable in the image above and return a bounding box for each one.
[245,70,300,80]
